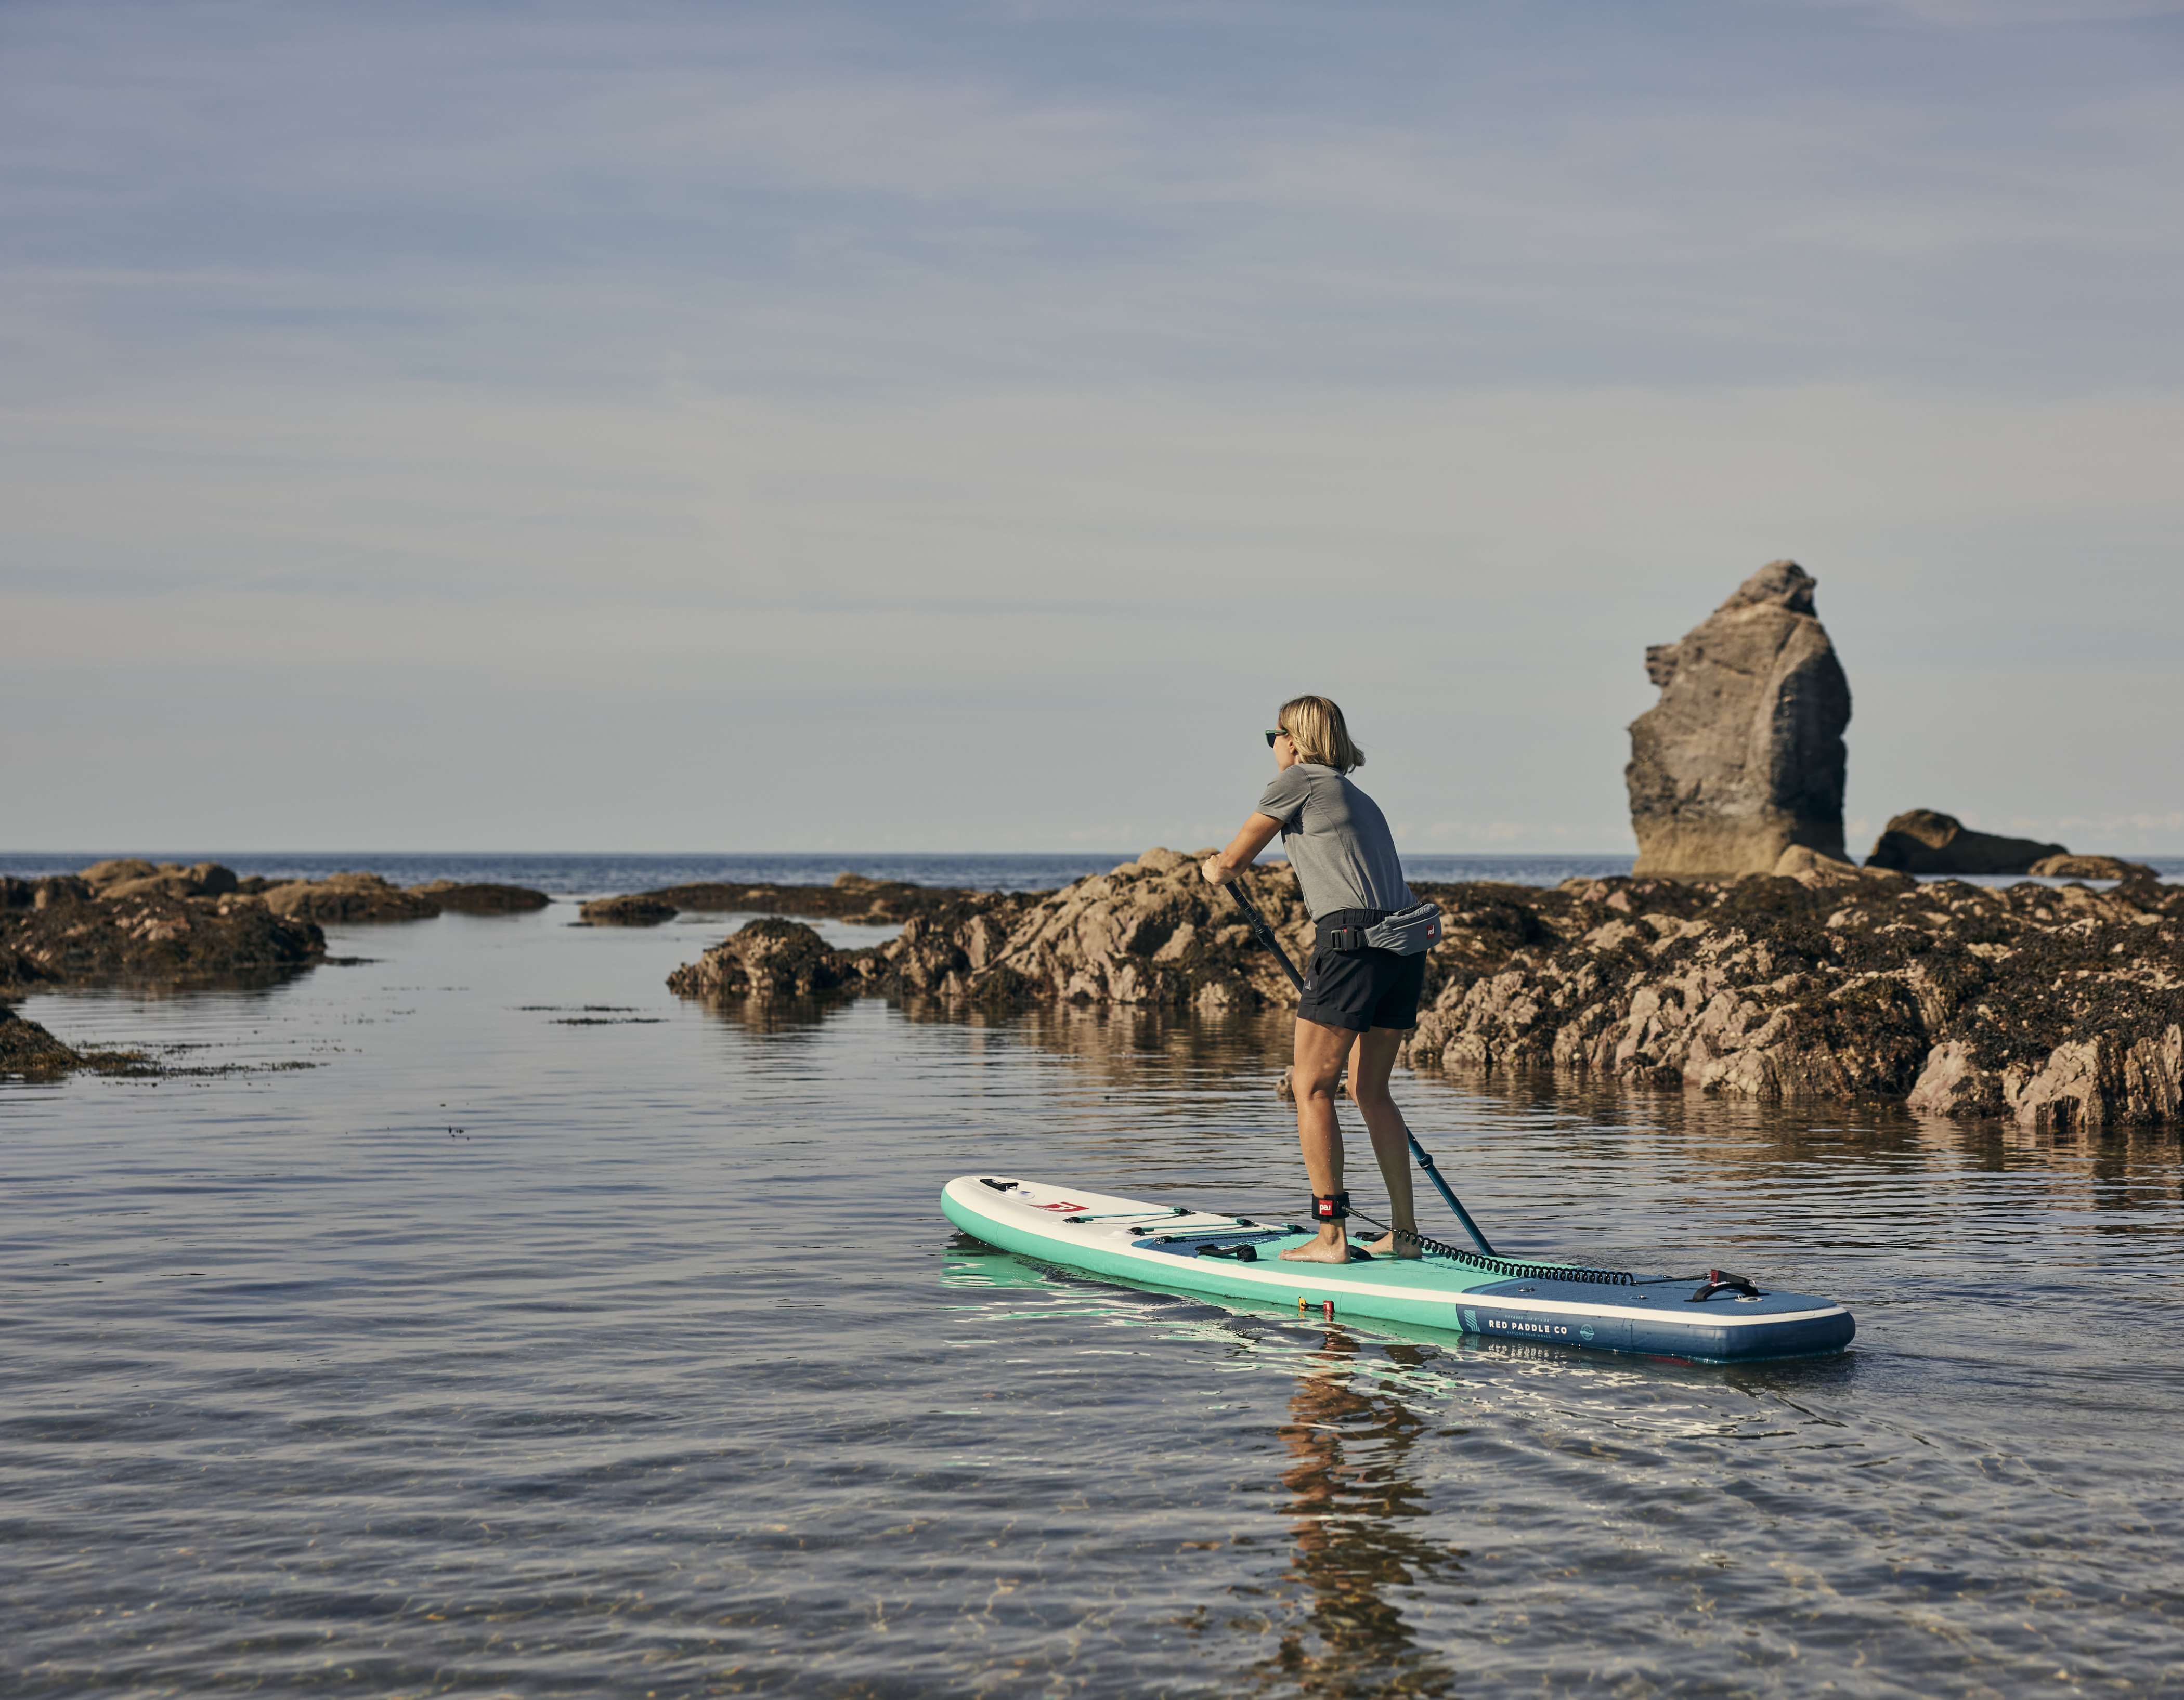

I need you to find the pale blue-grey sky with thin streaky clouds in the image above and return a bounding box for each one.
[0,0,2184,853]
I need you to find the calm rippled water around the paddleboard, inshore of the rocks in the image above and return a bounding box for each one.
[0,873,2184,1696]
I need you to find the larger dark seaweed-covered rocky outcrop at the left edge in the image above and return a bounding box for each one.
[0,880,326,991]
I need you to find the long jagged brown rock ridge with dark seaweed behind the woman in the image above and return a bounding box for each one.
[668,849,2184,1128]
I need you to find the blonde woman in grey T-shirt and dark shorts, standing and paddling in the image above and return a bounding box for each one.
[1203,696,1439,1263]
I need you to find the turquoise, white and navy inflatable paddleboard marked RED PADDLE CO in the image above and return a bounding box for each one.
[941,1174,1856,1359]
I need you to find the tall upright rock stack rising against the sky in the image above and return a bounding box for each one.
[1623,561,1850,880]
